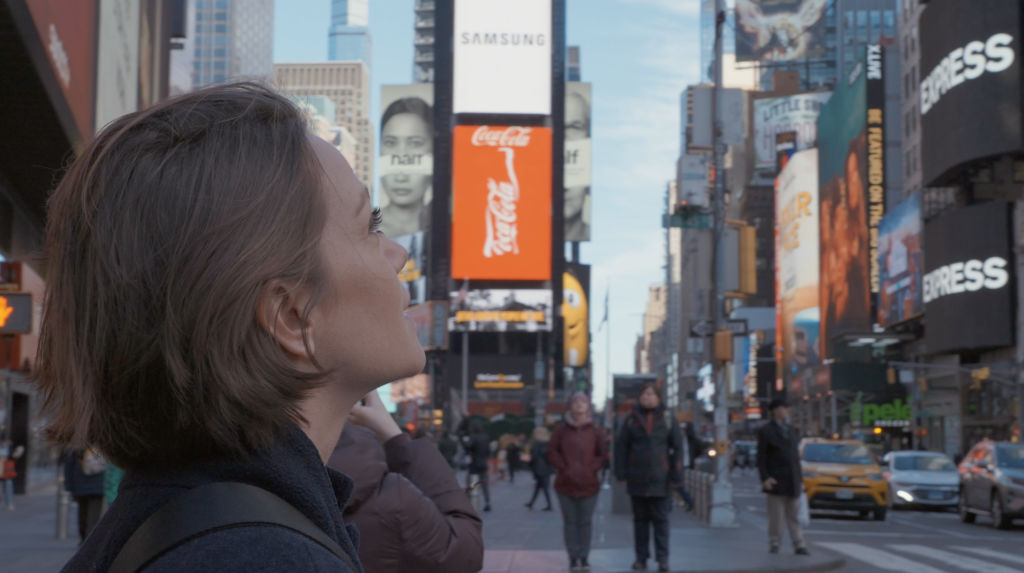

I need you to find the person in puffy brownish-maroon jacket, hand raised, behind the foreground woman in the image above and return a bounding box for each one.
[328,391,483,573]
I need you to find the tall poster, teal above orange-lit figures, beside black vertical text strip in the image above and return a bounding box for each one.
[818,60,872,358]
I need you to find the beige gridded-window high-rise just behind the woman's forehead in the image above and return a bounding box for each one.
[273,61,374,187]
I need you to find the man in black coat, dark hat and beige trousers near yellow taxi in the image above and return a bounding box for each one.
[758,398,809,555]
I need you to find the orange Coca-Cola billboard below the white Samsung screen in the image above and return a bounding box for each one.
[452,126,551,280]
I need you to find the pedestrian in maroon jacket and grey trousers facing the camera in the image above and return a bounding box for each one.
[548,392,608,571]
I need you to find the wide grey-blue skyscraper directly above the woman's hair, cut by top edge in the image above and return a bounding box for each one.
[191,0,273,88]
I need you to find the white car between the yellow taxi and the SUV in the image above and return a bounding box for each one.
[882,451,959,508]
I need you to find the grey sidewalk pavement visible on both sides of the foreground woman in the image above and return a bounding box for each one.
[0,472,844,573]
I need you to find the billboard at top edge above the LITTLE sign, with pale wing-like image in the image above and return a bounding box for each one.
[736,0,828,61]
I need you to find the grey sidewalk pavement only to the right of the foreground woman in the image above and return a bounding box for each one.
[482,473,845,573]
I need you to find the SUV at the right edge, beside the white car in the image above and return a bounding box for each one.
[958,440,1024,529]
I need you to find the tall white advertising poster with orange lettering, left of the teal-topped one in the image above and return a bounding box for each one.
[775,148,821,388]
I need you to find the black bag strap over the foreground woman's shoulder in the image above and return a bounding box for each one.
[110,482,359,573]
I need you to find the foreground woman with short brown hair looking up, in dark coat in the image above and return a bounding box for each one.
[34,83,425,573]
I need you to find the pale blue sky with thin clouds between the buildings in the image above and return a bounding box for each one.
[273,0,700,404]
